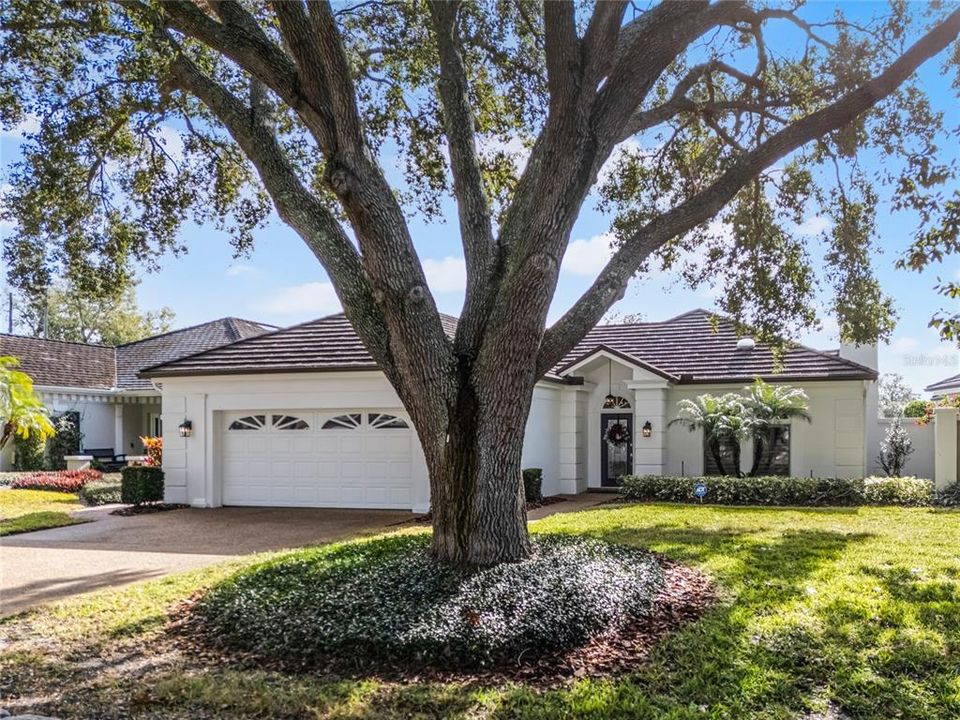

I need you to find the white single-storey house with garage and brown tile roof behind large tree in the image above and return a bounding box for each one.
[141,310,877,512]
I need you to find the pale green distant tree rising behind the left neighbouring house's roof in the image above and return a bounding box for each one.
[15,283,174,345]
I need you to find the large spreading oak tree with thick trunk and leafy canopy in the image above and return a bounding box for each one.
[0,0,960,564]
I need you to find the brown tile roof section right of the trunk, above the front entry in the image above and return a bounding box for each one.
[554,310,877,383]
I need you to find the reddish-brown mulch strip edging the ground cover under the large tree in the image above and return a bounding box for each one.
[167,553,720,688]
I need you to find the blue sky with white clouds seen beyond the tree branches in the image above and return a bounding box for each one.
[0,3,960,390]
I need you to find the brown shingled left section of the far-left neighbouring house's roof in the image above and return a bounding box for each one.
[0,334,117,390]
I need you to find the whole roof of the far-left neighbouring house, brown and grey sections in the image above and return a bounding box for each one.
[0,318,275,390]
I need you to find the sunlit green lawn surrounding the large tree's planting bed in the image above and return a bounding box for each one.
[0,505,960,720]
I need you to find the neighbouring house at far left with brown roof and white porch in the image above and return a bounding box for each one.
[0,318,276,469]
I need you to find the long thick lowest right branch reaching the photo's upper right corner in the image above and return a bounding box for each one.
[537,10,960,373]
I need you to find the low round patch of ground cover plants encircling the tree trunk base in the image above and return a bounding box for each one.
[196,535,663,667]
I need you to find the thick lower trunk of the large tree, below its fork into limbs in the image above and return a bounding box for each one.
[426,362,533,566]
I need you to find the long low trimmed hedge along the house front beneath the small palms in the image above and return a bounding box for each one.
[621,475,946,506]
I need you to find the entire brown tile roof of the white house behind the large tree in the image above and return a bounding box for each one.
[141,310,877,383]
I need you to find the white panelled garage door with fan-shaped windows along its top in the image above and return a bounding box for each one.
[220,410,414,510]
